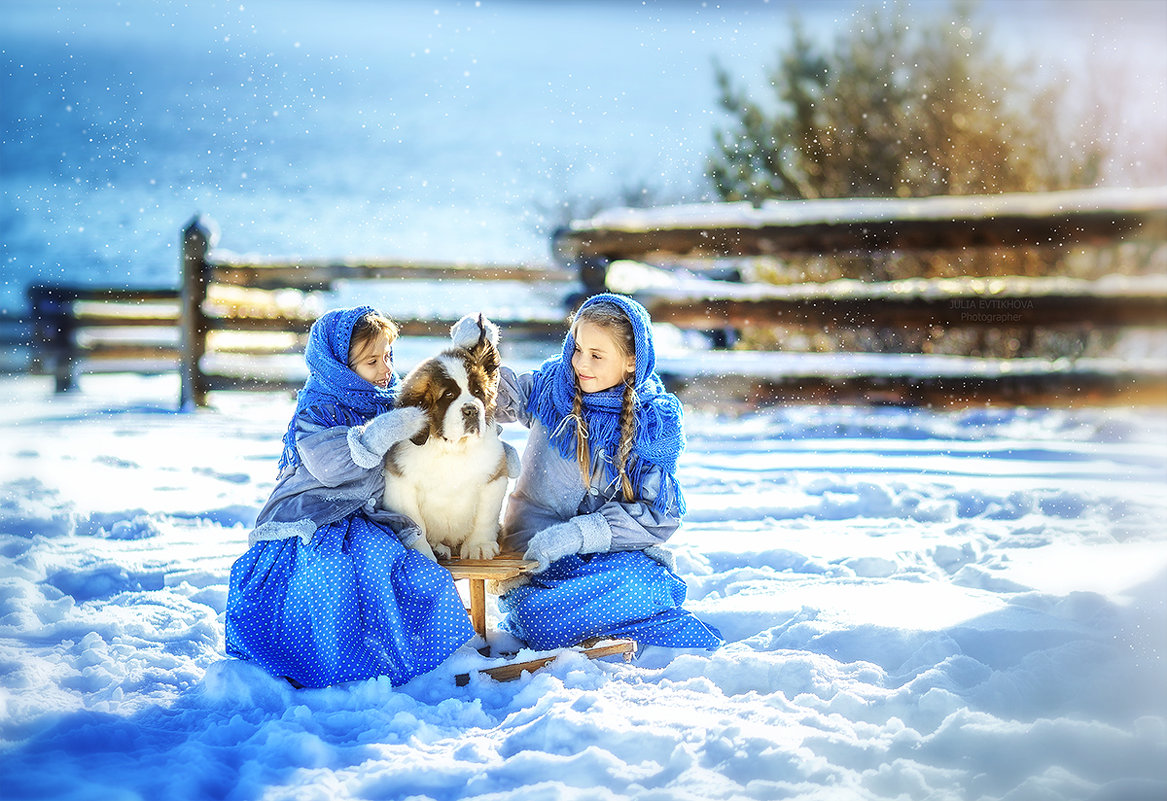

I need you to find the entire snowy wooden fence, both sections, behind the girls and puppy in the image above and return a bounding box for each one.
[29,187,1167,406]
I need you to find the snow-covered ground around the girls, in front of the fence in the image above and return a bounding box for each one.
[0,376,1167,801]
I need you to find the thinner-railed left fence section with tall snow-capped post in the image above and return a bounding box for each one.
[28,218,573,408]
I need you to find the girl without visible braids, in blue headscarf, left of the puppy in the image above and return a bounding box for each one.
[226,306,474,688]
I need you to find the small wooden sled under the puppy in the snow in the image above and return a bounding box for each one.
[438,553,636,687]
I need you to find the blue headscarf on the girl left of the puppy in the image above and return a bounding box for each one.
[280,306,397,469]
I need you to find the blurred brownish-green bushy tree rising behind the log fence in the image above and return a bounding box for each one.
[710,2,1106,210]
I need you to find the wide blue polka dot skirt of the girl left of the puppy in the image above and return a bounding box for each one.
[226,513,474,688]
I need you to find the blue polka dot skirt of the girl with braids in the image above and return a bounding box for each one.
[498,551,722,650]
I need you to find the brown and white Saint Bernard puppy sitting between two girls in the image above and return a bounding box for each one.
[382,315,508,560]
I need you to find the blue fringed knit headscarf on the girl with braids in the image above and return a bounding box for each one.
[526,293,685,514]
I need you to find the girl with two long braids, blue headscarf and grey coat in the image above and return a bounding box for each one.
[453,294,721,650]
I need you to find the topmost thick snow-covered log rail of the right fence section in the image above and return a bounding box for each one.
[554,187,1167,262]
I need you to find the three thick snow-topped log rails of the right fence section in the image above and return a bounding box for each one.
[554,187,1167,405]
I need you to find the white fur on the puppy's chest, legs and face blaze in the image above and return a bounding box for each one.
[382,354,508,559]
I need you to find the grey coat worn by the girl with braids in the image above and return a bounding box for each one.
[496,367,680,558]
